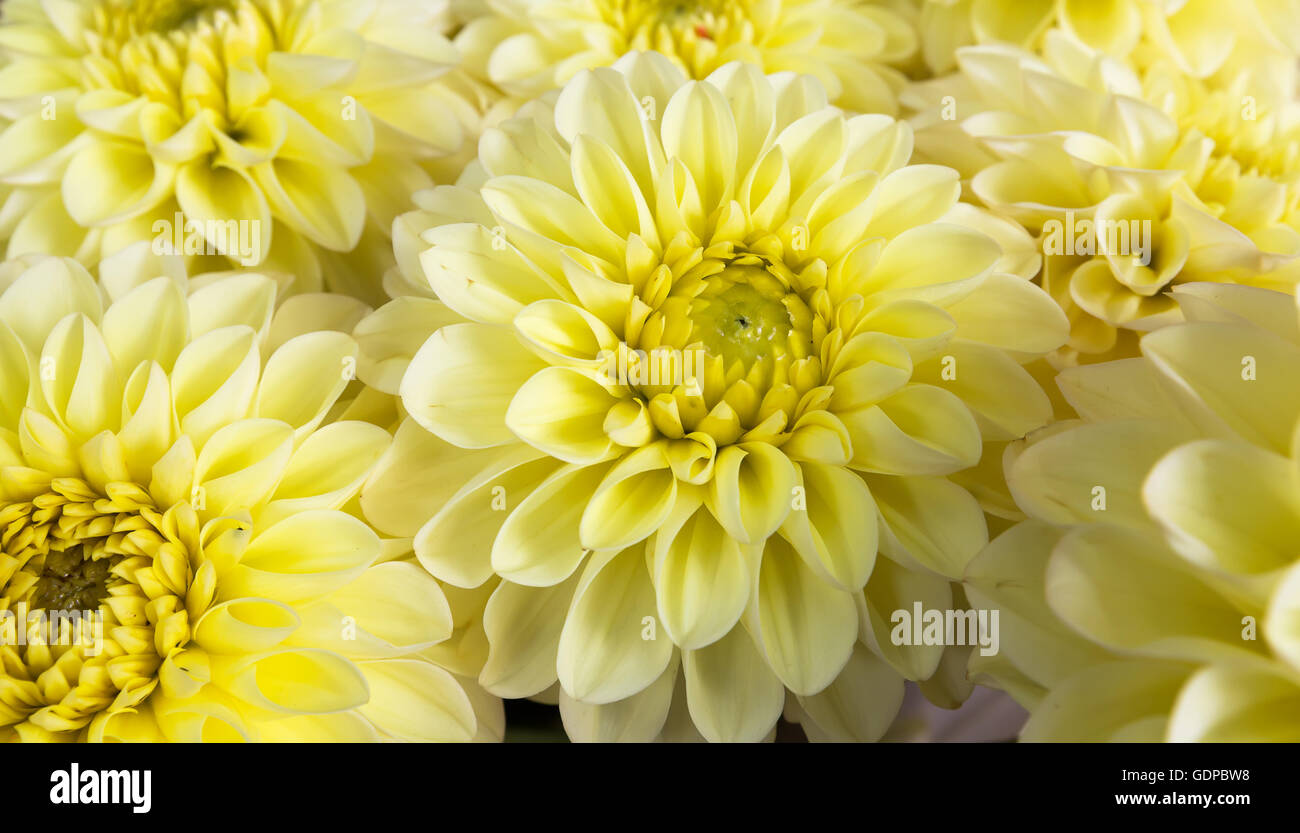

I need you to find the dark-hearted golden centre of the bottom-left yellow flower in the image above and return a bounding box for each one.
[0,477,198,737]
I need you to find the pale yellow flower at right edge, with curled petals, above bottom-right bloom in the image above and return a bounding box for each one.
[913,32,1300,363]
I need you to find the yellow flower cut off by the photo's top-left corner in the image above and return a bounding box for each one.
[0,0,473,299]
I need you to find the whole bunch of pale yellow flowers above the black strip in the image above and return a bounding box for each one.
[0,0,1300,742]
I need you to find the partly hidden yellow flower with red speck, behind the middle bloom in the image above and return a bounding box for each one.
[456,0,917,113]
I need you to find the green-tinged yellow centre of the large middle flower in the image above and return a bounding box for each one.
[618,240,832,446]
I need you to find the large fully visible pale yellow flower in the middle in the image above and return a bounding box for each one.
[356,53,1066,739]
